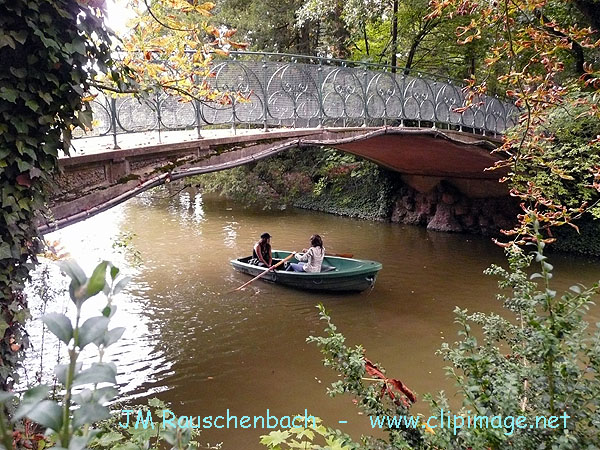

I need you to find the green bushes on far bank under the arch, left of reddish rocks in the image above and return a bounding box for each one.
[196,148,398,219]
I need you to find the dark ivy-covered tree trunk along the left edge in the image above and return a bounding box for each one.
[0,0,118,390]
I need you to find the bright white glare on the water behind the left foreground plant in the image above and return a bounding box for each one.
[23,205,172,400]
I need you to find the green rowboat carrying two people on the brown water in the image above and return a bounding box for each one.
[231,250,383,292]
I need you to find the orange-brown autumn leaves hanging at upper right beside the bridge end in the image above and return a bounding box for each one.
[428,0,600,242]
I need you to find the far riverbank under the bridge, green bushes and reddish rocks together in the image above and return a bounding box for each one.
[194,148,600,256]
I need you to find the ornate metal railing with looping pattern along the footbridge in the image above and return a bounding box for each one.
[78,52,517,146]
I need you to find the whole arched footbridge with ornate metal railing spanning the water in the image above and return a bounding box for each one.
[40,52,518,231]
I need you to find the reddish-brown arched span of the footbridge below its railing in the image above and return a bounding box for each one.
[40,127,498,232]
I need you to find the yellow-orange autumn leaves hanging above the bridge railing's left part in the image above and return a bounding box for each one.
[104,0,247,103]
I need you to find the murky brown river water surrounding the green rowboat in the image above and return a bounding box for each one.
[30,188,600,450]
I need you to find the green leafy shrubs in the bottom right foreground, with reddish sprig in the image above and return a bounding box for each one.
[279,229,600,450]
